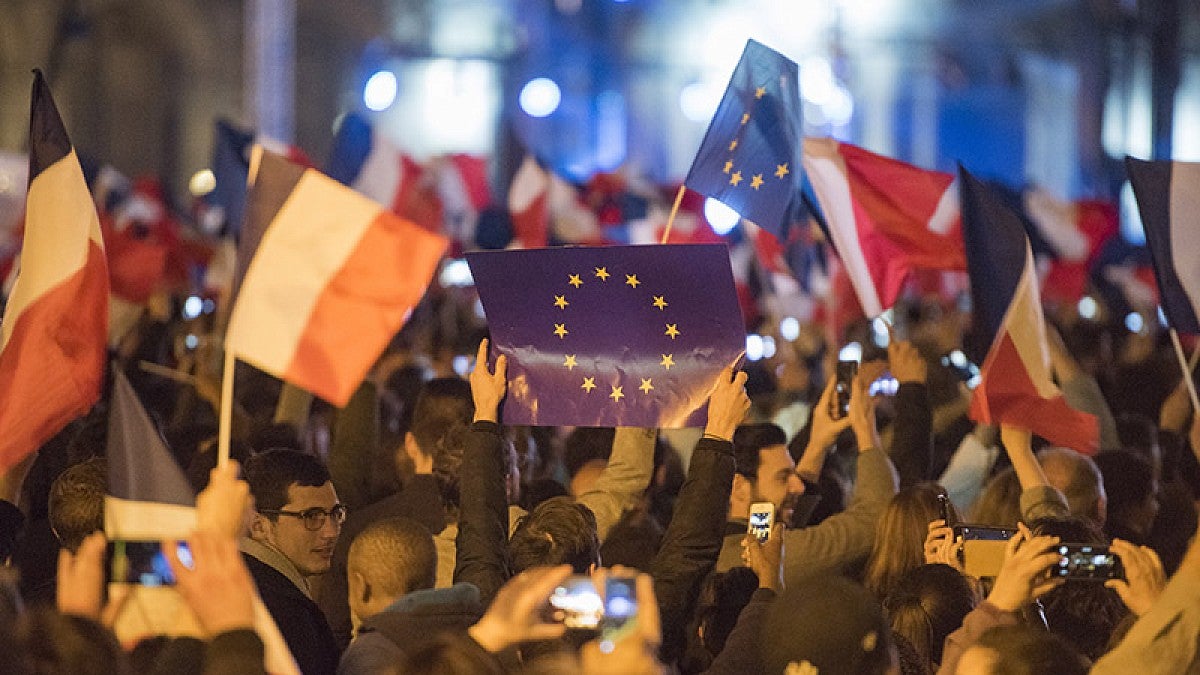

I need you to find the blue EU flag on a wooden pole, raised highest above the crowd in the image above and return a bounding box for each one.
[684,40,803,241]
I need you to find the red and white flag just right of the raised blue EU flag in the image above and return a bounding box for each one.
[804,138,966,317]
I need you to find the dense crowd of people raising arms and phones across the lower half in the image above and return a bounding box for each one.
[0,275,1200,675]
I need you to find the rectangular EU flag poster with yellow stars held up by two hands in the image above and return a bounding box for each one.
[467,244,745,428]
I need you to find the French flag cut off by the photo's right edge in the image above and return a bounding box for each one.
[1126,157,1200,335]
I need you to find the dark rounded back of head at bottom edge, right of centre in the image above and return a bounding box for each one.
[760,577,893,675]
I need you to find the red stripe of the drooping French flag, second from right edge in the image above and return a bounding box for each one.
[970,329,1099,454]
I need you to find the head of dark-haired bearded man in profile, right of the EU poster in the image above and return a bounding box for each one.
[730,422,804,522]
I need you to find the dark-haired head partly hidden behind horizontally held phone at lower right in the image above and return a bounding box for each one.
[1030,516,1129,659]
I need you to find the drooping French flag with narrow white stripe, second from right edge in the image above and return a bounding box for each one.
[959,167,1099,454]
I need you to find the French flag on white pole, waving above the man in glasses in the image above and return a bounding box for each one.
[226,151,446,406]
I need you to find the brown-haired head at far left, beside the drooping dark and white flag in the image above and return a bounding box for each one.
[49,458,108,552]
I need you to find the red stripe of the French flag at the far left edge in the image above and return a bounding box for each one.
[0,241,108,471]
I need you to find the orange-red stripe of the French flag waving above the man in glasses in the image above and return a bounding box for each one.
[282,213,446,407]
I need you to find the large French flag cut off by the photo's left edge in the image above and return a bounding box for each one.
[0,71,108,471]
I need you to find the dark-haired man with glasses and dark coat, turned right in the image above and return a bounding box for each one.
[241,449,346,675]
